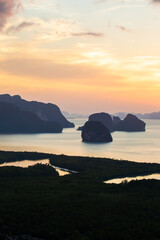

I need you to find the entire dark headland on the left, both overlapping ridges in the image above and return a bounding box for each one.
[0,94,74,133]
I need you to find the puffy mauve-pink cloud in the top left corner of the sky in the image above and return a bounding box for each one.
[0,0,22,30]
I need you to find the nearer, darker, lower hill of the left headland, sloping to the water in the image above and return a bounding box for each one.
[0,102,62,133]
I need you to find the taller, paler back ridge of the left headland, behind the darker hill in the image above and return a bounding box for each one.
[0,94,74,128]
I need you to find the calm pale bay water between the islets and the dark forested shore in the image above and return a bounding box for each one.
[0,119,160,163]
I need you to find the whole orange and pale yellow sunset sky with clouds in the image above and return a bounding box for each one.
[0,0,160,114]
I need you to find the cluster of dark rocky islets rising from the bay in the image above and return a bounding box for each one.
[77,112,146,142]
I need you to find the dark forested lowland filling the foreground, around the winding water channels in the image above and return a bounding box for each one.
[0,152,160,240]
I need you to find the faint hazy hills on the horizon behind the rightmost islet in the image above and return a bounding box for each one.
[114,112,160,119]
